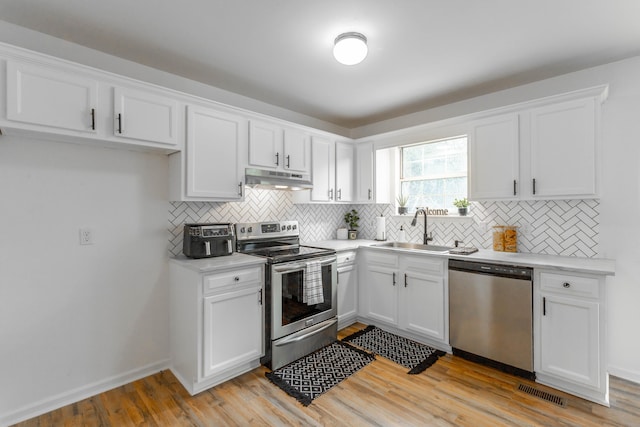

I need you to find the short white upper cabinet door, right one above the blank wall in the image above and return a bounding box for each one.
[113,87,178,146]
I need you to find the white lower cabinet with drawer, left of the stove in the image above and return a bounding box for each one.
[170,257,264,395]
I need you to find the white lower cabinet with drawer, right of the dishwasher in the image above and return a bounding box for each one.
[534,270,609,405]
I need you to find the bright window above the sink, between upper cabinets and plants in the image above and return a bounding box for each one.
[400,136,467,212]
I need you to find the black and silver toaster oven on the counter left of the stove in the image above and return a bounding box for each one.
[182,223,235,258]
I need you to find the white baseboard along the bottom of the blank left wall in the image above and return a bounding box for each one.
[0,359,170,426]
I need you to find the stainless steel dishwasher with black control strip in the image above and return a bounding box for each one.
[449,259,535,379]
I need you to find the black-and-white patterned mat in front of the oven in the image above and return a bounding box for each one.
[265,341,375,406]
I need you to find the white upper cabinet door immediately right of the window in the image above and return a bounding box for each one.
[468,114,521,200]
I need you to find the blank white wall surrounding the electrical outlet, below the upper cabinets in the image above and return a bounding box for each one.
[0,136,169,425]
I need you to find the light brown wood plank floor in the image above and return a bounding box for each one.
[13,324,640,427]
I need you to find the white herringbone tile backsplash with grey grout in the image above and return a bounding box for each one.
[169,192,600,258]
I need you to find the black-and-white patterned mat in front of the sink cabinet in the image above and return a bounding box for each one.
[342,325,445,375]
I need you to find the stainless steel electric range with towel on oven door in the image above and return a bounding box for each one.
[235,221,338,369]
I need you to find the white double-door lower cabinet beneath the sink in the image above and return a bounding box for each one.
[359,249,449,347]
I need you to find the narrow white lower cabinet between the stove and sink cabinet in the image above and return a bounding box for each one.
[337,251,358,329]
